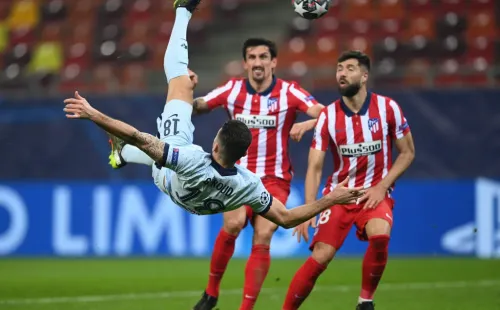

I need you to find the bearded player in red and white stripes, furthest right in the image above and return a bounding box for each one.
[283,51,415,310]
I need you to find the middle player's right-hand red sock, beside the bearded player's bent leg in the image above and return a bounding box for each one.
[240,244,271,310]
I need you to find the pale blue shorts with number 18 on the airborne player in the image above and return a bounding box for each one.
[152,99,194,195]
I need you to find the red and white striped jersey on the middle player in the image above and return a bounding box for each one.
[203,78,317,181]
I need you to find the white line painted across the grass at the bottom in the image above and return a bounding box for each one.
[0,280,500,305]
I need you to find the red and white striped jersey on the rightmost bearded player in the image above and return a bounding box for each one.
[311,92,410,194]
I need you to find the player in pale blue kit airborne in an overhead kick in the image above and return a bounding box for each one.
[64,0,363,228]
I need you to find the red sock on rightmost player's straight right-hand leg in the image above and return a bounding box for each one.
[359,235,390,299]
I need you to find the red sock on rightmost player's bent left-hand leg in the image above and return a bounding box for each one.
[283,257,326,310]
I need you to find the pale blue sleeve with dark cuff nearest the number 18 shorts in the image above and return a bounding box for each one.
[156,143,206,175]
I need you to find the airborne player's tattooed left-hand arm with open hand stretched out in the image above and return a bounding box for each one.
[64,91,165,162]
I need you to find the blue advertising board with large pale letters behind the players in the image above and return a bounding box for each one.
[0,179,500,258]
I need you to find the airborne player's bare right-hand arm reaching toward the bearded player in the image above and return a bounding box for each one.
[261,177,364,228]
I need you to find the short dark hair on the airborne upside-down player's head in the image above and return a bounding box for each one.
[218,120,252,163]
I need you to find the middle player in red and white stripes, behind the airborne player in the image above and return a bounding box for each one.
[189,38,324,310]
